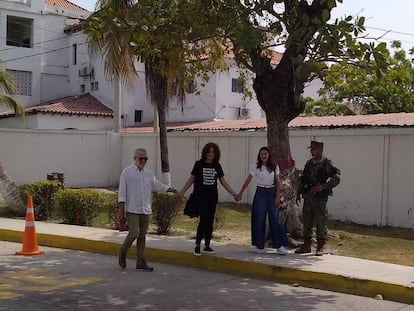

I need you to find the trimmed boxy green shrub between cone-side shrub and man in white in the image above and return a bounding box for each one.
[55,189,103,226]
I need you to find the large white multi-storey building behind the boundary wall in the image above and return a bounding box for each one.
[0,0,314,129]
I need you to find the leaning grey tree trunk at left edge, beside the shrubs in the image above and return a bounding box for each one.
[0,162,26,216]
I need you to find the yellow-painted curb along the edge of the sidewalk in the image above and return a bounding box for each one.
[0,229,414,304]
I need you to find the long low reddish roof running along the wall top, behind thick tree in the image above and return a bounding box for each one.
[124,112,414,133]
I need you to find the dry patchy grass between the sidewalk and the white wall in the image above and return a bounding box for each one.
[93,203,414,266]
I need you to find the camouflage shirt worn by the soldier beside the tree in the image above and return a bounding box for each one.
[298,158,341,196]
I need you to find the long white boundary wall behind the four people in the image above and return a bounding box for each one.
[0,128,414,229]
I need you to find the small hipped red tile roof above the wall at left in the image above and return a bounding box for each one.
[0,93,113,119]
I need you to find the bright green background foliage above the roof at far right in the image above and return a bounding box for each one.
[321,41,414,113]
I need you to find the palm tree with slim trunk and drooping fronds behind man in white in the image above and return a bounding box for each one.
[84,0,217,184]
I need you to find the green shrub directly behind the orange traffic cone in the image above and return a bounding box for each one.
[19,180,60,220]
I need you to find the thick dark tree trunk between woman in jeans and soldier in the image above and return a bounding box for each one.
[252,50,304,244]
